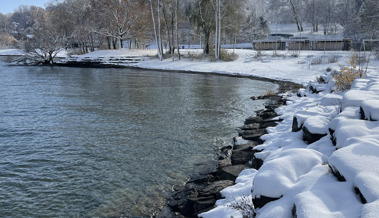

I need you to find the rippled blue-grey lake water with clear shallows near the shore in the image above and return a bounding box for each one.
[0,63,277,217]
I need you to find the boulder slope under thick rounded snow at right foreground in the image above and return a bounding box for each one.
[202,61,379,217]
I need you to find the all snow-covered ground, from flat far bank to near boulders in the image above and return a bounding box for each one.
[0,49,379,218]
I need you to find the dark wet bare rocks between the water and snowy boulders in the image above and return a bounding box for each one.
[157,81,302,217]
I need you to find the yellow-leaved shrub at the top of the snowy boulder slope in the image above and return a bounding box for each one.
[333,50,366,91]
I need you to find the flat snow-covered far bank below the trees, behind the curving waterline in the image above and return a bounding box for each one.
[60,49,376,85]
